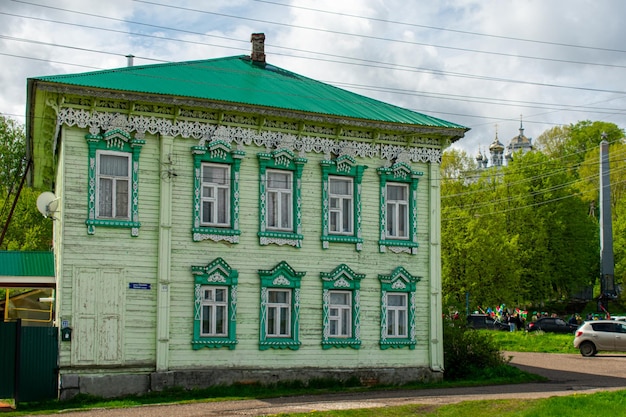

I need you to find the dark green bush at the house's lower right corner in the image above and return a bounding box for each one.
[443,319,508,381]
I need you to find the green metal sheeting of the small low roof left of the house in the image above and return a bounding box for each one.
[0,251,54,277]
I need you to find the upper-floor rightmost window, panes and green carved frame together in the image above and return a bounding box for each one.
[378,162,423,255]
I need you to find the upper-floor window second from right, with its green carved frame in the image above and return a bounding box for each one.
[321,155,367,251]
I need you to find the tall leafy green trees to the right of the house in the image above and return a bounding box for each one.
[441,121,626,308]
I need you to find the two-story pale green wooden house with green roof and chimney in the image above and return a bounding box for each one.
[27,34,467,398]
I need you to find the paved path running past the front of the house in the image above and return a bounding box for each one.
[20,352,626,417]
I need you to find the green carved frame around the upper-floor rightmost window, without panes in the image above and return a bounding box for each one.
[378,162,424,255]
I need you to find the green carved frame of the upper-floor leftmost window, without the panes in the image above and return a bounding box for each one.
[85,129,146,237]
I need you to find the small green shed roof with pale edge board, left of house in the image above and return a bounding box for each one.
[0,251,55,287]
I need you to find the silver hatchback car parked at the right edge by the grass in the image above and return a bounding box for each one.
[574,320,626,356]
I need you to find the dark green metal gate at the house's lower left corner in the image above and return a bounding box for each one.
[0,319,59,404]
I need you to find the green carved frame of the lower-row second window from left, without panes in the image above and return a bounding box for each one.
[258,261,306,350]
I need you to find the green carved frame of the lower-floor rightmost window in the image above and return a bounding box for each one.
[378,266,421,350]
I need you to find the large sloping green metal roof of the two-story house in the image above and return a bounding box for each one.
[34,55,468,130]
